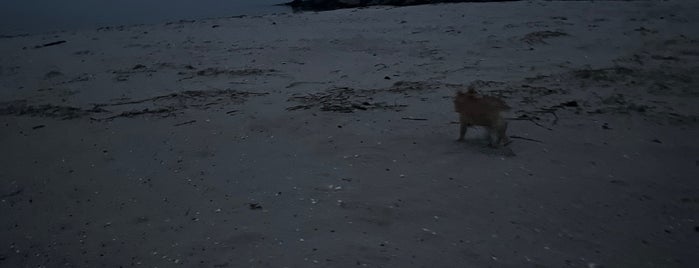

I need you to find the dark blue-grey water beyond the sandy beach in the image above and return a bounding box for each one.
[0,0,291,35]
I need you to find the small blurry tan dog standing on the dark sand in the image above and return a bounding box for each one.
[454,86,510,147]
